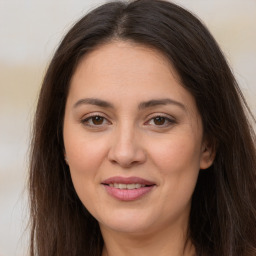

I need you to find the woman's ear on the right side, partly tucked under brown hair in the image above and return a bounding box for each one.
[200,141,216,169]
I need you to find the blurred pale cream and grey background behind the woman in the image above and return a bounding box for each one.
[0,0,256,256]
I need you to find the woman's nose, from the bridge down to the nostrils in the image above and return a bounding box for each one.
[108,124,146,168]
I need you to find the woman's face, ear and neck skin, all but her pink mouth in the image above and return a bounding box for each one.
[63,41,214,256]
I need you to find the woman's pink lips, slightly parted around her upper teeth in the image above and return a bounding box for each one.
[102,176,156,201]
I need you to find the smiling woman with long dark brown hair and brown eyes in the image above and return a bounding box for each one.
[29,0,256,256]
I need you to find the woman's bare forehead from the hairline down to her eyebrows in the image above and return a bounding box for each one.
[68,41,194,114]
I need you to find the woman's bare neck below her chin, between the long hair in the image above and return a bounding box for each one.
[101,222,196,256]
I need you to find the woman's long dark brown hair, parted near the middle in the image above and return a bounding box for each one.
[29,0,256,256]
